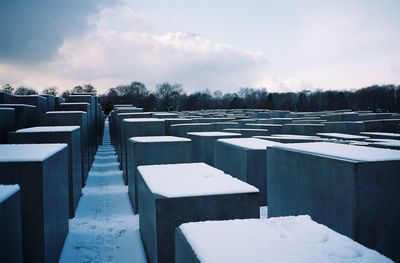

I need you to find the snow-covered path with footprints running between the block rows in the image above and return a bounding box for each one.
[60,122,146,263]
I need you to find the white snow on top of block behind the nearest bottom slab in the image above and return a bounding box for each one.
[138,163,258,198]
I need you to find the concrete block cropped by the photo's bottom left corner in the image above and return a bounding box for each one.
[0,184,23,263]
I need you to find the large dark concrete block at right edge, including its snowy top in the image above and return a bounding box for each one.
[267,143,400,261]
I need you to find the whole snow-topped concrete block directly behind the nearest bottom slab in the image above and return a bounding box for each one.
[138,163,260,262]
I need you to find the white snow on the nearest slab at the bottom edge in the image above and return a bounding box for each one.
[179,216,392,263]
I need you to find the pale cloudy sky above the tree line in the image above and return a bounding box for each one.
[0,0,400,93]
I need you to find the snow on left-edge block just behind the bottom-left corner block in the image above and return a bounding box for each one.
[0,143,67,162]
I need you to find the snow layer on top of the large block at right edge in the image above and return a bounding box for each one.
[273,142,400,162]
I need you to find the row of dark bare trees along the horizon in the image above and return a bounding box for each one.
[2,81,400,113]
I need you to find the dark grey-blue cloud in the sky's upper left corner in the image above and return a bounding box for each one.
[0,0,112,63]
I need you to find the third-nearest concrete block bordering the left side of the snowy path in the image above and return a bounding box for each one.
[40,111,91,186]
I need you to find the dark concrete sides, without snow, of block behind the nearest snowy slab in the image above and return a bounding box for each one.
[138,164,260,262]
